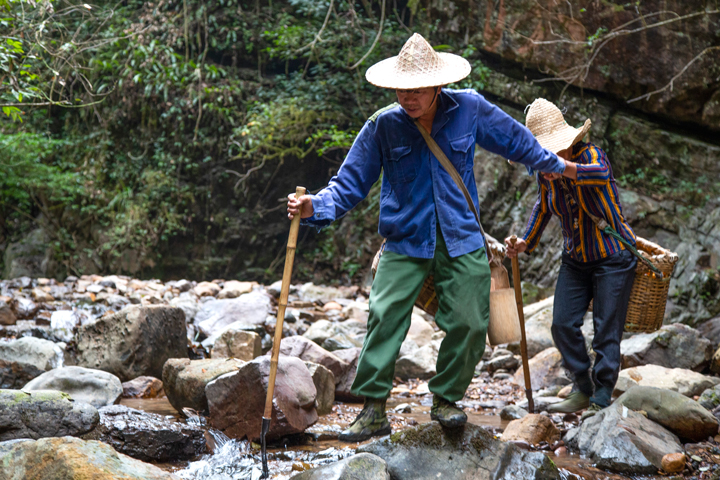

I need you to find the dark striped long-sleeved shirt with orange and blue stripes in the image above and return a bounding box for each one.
[523,142,635,262]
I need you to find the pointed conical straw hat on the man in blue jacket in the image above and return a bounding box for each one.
[365,33,471,90]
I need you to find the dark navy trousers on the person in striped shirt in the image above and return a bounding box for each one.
[552,250,637,407]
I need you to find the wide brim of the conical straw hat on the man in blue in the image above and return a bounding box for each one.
[365,52,472,90]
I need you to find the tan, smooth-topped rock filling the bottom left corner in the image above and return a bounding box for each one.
[0,437,180,480]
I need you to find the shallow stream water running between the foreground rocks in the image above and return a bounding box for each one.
[121,397,667,480]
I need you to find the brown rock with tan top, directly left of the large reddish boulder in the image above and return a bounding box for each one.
[162,358,244,412]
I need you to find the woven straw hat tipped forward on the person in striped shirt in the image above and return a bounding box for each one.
[525,98,592,153]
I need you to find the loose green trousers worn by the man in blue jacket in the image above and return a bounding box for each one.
[352,228,490,402]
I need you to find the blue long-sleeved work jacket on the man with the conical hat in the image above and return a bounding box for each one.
[303,89,565,258]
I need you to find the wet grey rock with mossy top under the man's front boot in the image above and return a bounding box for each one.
[357,422,560,480]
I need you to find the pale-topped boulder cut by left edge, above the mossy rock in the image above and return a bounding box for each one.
[0,337,65,388]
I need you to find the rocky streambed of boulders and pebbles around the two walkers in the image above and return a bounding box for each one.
[0,276,720,480]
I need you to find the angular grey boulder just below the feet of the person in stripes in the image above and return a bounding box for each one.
[564,404,682,475]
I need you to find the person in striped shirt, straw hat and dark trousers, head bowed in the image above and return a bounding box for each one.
[506,98,637,419]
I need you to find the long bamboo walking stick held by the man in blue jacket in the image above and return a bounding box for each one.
[260,187,305,478]
